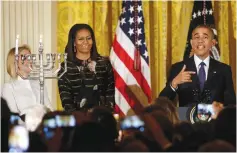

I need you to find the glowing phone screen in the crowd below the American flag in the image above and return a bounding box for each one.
[120,116,145,131]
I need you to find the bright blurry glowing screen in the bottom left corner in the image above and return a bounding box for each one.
[8,125,29,152]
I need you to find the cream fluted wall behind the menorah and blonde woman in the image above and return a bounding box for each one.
[0,1,57,108]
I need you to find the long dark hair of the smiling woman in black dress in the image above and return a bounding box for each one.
[65,24,99,61]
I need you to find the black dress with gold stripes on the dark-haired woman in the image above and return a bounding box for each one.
[58,56,115,112]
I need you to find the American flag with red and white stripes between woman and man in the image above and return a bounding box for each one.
[110,1,151,115]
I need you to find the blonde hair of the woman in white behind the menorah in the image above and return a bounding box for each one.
[7,45,31,79]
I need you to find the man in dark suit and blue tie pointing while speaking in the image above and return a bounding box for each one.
[159,25,236,107]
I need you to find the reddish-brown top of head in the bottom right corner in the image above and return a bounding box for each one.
[198,140,236,152]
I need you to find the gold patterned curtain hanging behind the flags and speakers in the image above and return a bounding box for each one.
[57,1,236,110]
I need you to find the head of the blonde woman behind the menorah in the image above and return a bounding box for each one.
[6,45,31,79]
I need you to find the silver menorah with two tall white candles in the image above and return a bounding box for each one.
[15,35,67,104]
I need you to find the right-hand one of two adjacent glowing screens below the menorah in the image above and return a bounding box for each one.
[55,115,76,127]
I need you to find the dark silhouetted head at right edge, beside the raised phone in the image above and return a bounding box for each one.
[215,106,236,147]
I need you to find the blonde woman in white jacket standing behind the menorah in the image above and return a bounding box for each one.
[2,45,53,115]
